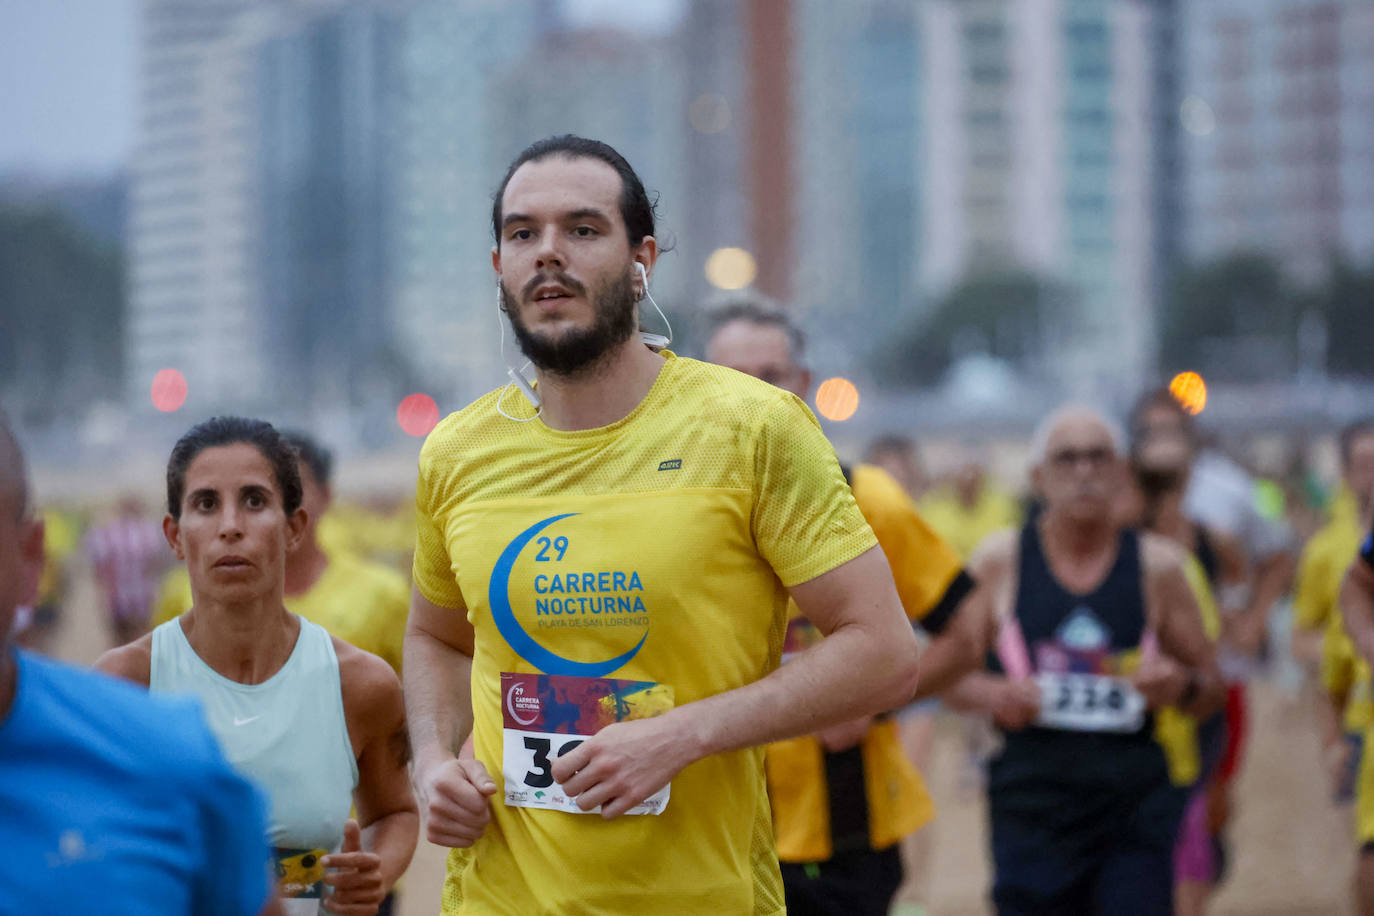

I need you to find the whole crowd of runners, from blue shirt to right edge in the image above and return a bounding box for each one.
[0,136,1374,916]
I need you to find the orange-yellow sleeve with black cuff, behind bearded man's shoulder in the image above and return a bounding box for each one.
[853,464,973,633]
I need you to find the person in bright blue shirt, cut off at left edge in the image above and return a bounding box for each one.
[0,415,280,916]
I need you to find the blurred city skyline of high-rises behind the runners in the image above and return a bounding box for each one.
[0,0,1374,458]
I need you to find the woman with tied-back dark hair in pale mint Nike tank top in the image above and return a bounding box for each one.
[98,417,419,916]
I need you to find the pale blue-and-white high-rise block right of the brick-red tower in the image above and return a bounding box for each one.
[794,0,1160,385]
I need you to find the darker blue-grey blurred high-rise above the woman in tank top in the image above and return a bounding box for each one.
[254,3,408,407]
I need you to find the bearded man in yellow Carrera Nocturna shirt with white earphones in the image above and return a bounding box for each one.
[405,136,918,916]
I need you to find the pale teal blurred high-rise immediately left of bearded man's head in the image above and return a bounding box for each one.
[390,0,552,409]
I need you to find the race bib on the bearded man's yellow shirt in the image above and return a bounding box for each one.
[502,673,673,814]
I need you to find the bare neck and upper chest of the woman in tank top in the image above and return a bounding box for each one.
[181,595,301,684]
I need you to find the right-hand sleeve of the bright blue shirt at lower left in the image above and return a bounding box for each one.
[185,710,275,916]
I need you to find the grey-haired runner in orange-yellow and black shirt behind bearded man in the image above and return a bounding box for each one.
[706,299,988,916]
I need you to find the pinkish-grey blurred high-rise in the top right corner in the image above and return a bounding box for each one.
[1179,0,1374,282]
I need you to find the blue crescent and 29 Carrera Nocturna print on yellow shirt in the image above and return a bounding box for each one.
[486,512,649,677]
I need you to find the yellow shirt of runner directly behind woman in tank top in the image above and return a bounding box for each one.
[153,552,411,674]
